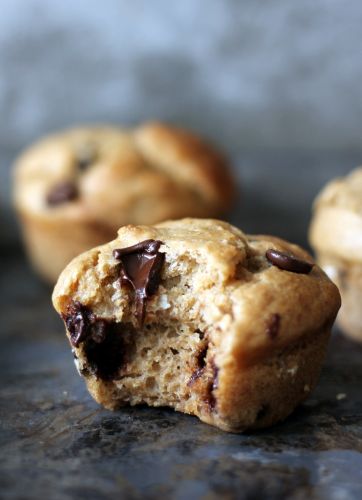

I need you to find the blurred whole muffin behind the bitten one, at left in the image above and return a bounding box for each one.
[14,123,234,283]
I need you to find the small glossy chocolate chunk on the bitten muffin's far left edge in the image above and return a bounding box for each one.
[63,301,107,347]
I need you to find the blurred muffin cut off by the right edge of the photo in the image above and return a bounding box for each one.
[310,168,362,342]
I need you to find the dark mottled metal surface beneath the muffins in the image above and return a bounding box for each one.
[0,248,362,500]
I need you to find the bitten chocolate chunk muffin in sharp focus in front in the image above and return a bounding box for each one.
[53,219,340,431]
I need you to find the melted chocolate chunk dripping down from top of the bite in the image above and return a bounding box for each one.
[113,240,165,326]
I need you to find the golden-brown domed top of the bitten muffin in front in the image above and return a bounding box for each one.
[53,219,340,366]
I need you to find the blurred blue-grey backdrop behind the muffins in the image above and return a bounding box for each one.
[0,0,362,244]
